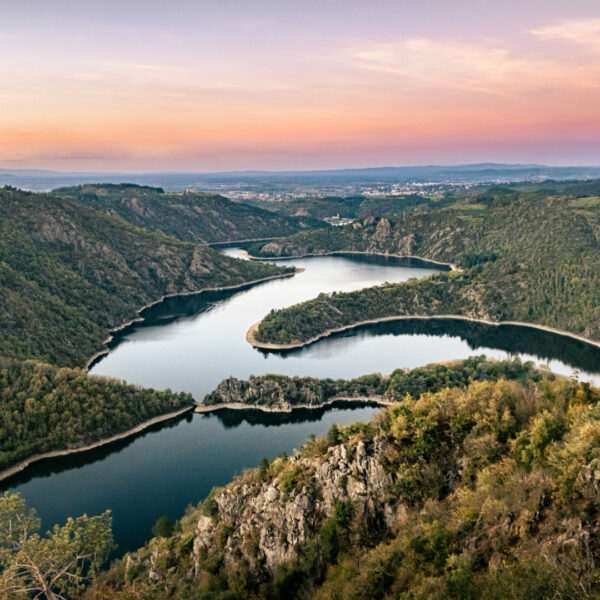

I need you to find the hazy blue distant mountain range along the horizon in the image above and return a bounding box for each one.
[0,163,600,191]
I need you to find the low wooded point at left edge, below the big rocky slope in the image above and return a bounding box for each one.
[0,358,192,470]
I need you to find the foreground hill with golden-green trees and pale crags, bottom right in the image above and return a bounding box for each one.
[84,371,600,600]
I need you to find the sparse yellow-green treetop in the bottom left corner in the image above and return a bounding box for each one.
[0,492,115,600]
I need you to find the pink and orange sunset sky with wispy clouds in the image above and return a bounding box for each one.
[0,0,600,172]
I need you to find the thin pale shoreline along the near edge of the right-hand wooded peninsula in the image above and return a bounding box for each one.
[246,315,600,351]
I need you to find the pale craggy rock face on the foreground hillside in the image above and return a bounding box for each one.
[193,437,402,574]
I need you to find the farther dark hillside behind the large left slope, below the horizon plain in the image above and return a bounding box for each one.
[53,184,327,243]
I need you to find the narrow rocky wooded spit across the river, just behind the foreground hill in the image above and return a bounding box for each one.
[202,356,542,411]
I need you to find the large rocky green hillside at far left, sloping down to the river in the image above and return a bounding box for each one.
[0,188,290,366]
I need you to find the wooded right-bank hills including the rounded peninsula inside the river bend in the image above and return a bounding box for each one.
[250,181,600,344]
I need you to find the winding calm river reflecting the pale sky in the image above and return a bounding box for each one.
[4,248,600,552]
